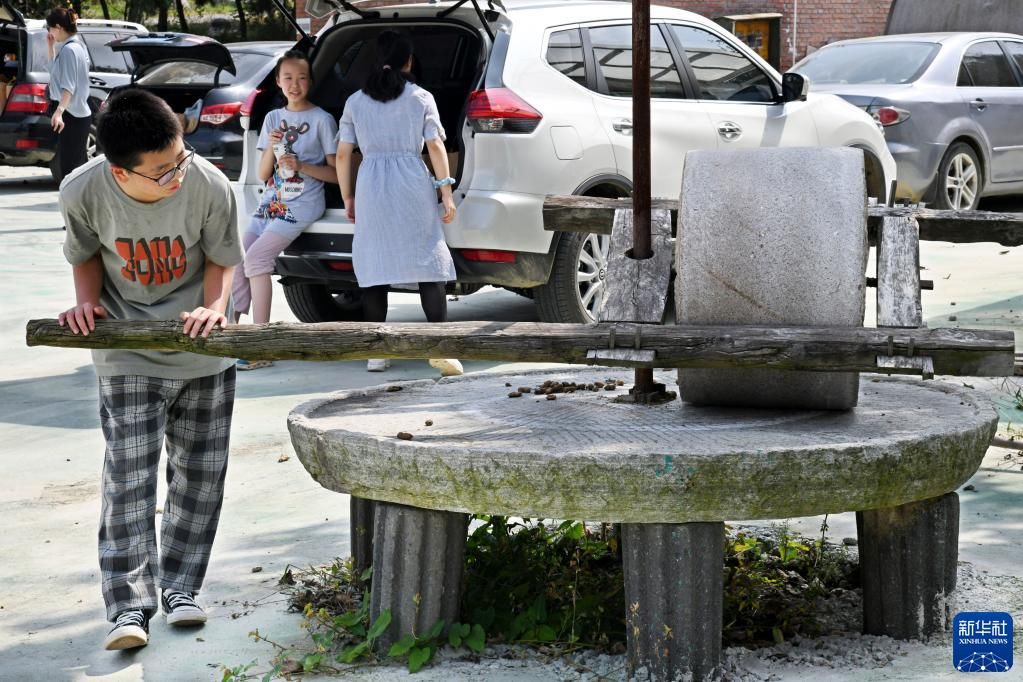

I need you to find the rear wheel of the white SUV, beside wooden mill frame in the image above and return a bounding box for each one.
[533,232,611,323]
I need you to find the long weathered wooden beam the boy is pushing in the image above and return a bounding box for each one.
[27,319,1014,376]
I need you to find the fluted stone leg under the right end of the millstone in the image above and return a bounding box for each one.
[856,493,959,639]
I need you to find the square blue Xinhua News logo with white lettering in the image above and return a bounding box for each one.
[952,611,1013,673]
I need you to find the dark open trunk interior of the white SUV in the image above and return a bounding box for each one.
[250,19,486,209]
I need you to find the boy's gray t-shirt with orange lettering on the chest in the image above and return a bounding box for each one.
[60,155,242,379]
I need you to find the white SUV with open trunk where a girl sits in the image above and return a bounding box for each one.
[236,0,895,322]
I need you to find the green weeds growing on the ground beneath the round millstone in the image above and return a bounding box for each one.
[222,515,858,682]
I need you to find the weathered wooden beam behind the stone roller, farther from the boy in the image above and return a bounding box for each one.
[543,194,1023,246]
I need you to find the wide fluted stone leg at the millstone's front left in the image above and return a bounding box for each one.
[369,502,469,652]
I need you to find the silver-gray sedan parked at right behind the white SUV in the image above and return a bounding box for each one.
[792,33,1023,209]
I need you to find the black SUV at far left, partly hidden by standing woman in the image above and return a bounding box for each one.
[0,0,147,178]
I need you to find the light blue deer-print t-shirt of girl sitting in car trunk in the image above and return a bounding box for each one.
[255,106,338,224]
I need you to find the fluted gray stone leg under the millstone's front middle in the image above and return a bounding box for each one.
[622,522,724,682]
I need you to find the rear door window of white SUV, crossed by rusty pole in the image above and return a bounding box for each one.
[589,25,685,99]
